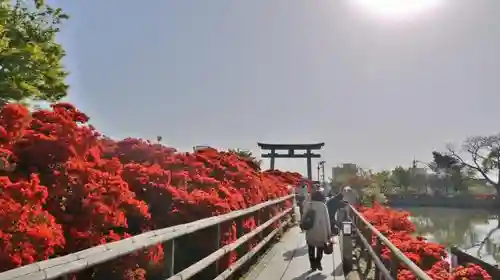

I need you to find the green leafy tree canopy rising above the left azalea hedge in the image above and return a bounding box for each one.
[0,0,68,104]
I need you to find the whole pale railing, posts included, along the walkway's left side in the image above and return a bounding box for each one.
[0,194,296,280]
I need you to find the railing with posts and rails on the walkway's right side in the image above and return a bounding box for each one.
[342,206,432,280]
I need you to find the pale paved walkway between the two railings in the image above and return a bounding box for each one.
[244,227,345,280]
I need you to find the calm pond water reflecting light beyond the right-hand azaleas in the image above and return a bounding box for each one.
[404,207,500,264]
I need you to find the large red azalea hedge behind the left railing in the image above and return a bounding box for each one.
[0,103,301,279]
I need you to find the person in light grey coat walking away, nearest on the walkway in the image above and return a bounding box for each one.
[304,191,332,271]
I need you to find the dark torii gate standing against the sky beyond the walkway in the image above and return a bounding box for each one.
[257,143,325,180]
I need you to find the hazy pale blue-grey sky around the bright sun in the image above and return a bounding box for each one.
[47,0,500,178]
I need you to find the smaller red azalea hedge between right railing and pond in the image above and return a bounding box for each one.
[359,204,492,280]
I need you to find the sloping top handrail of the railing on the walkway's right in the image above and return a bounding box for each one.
[349,205,432,280]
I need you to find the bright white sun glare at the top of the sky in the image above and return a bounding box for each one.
[352,0,442,19]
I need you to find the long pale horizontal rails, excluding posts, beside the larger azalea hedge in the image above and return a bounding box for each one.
[0,194,295,280]
